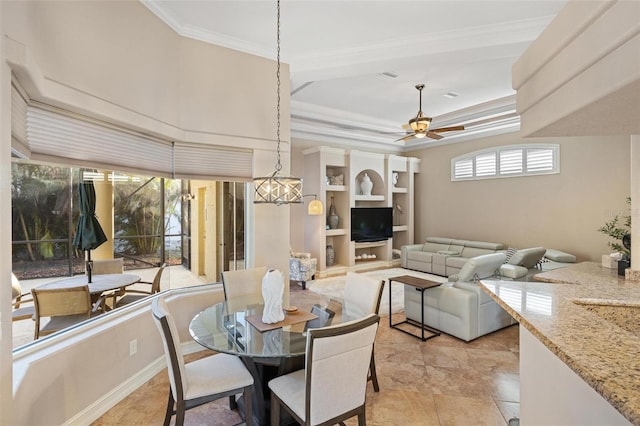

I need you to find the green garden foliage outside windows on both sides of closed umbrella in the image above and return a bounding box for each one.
[11,162,182,279]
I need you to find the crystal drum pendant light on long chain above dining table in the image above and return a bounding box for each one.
[253,0,303,205]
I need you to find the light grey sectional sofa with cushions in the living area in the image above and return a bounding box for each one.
[400,237,576,342]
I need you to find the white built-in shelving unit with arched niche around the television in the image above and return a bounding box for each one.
[303,147,419,278]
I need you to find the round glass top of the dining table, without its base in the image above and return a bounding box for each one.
[189,295,353,358]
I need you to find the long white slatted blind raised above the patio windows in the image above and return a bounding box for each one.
[20,105,253,180]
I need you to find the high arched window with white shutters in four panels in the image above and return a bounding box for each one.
[451,144,560,181]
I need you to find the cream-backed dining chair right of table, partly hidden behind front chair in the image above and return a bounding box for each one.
[342,272,384,392]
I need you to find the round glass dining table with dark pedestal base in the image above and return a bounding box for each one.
[189,292,355,425]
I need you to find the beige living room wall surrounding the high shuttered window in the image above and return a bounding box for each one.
[410,133,630,261]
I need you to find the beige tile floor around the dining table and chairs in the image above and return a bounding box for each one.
[93,286,520,426]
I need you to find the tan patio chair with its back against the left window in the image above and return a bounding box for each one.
[31,285,104,340]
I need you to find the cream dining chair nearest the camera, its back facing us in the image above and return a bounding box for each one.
[269,314,380,425]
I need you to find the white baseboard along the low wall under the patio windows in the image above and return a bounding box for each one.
[64,342,203,426]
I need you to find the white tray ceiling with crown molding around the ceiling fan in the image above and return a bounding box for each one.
[142,0,566,151]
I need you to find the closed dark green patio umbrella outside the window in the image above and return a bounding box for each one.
[73,181,107,282]
